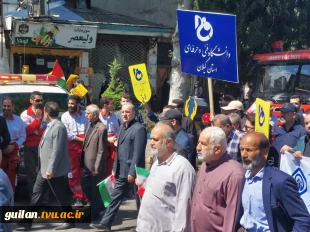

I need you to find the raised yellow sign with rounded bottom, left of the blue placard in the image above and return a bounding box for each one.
[128,64,152,102]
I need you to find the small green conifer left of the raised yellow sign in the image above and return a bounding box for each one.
[101,59,125,110]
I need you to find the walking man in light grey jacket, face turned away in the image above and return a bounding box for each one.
[18,102,75,230]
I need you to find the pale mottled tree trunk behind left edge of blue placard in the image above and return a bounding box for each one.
[169,0,193,103]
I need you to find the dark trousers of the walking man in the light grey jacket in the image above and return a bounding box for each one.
[28,171,74,223]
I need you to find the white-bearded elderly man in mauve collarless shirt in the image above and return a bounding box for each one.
[191,127,244,232]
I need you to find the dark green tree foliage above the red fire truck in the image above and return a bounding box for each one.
[194,0,310,81]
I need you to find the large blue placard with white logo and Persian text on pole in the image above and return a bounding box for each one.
[177,10,239,83]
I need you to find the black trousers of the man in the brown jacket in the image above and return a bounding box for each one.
[81,167,104,221]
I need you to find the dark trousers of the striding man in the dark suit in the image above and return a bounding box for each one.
[100,177,140,228]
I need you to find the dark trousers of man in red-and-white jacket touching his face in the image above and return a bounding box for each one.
[24,146,50,203]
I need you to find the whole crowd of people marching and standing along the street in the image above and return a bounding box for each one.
[0,86,310,232]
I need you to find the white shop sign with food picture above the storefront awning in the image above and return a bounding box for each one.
[13,22,97,49]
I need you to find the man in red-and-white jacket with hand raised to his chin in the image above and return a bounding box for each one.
[20,91,47,197]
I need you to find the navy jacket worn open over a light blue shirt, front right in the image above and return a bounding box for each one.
[234,166,310,232]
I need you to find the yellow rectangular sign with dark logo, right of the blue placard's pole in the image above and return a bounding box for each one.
[255,98,270,138]
